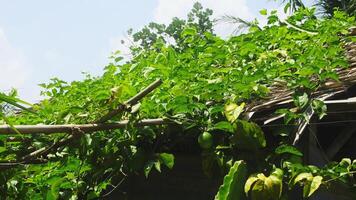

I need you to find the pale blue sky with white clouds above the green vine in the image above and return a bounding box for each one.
[0,0,312,102]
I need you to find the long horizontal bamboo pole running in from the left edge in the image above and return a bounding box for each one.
[0,118,167,135]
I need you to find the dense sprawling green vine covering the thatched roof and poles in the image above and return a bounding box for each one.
[0,2,356,199]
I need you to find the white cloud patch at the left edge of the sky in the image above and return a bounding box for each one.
[0,28,29,95]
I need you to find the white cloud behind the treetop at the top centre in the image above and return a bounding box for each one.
[154,0,254,36]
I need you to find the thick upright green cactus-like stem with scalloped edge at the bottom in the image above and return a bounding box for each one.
[215,161,247,200]
